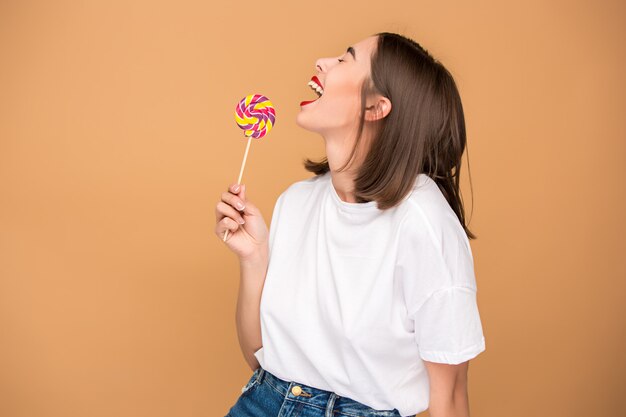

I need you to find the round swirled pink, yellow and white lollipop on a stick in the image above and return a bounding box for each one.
[224,94,276,242]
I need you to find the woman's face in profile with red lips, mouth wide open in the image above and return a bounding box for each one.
[296,36,377,136]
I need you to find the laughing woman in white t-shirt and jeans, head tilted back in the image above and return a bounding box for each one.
[215,33,485,417]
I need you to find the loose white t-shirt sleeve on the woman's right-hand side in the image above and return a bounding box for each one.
[398,205,485,365]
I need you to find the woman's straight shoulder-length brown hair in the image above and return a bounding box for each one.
[304,32,476,239]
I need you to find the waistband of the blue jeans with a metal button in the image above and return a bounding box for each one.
[255,367,401,417]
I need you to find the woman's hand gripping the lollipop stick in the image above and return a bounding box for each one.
[215,184,269,260]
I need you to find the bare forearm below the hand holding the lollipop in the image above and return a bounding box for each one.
[235,250,269,371]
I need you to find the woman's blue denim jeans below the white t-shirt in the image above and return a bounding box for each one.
[226,367,401,417]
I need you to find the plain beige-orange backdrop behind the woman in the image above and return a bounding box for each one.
[0,0,626,417]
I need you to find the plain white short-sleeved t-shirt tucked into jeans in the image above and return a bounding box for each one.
[254,173,485,416]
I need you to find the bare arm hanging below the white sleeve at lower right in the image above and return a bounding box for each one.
[424,361,469,417]
